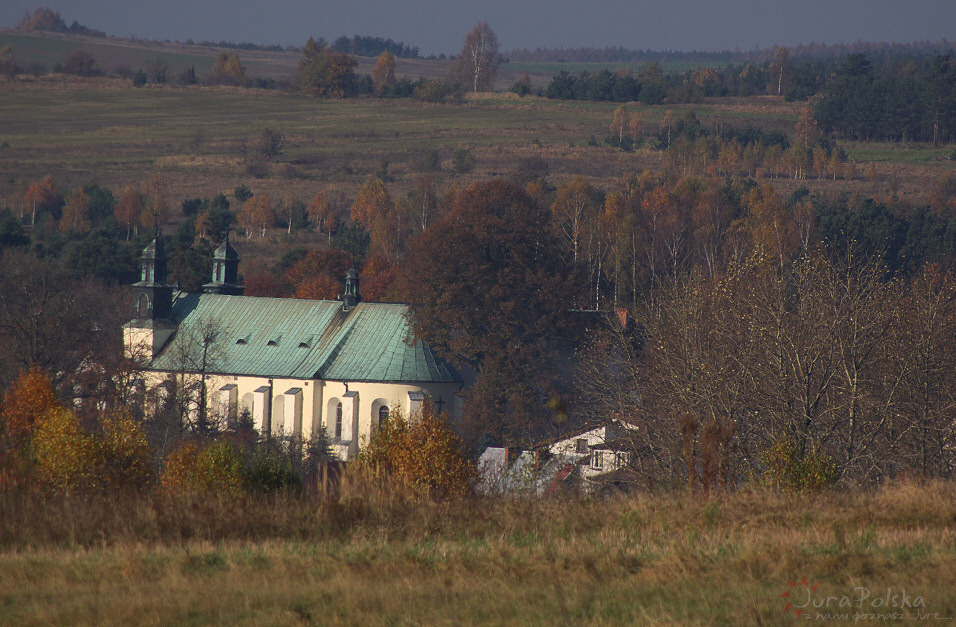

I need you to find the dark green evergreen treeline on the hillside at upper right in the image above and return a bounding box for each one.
[540,49,956,146]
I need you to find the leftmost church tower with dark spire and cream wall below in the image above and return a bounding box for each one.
[123,237,176,361]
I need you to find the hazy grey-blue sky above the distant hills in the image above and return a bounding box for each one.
[0,0,956,54]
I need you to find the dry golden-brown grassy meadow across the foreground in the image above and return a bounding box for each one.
[0,483,956,625]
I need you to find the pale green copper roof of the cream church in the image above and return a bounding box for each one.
[150,294,461,382]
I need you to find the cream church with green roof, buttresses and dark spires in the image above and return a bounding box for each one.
[123,238,462,460]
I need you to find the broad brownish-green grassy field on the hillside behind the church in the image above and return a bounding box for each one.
[0,80,663,202]
